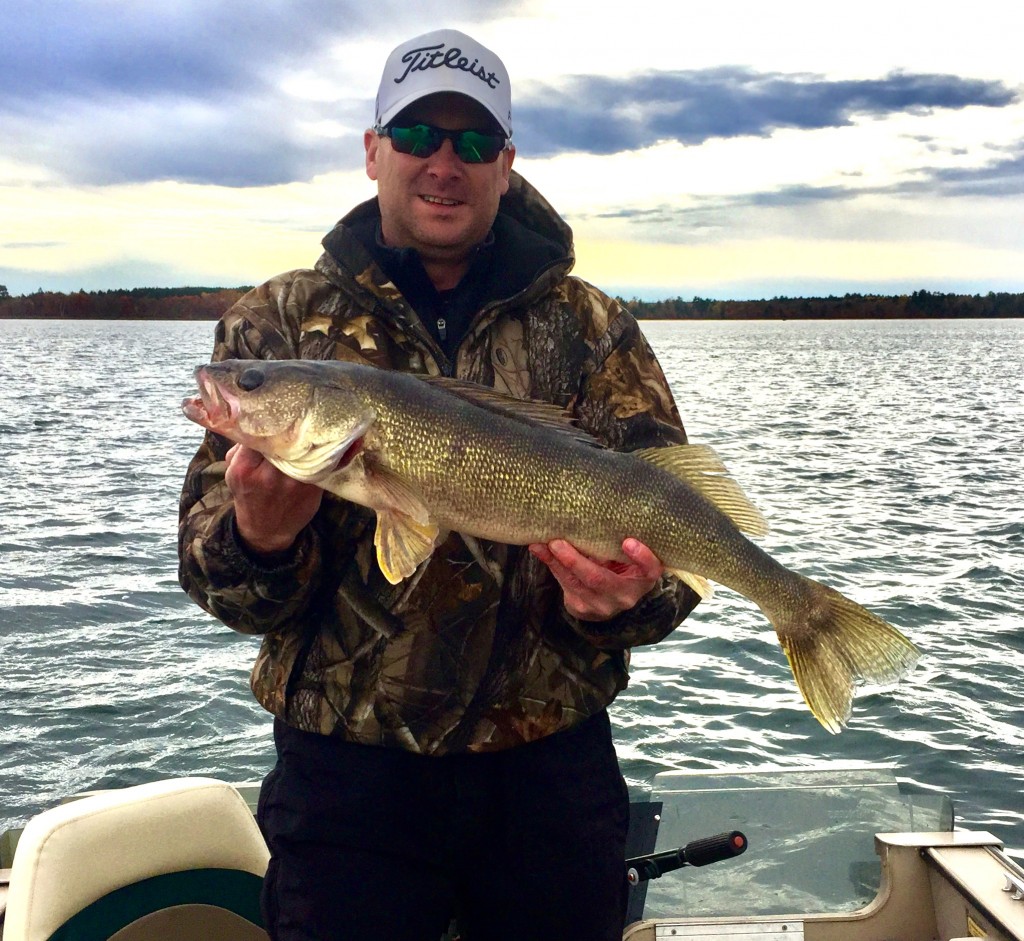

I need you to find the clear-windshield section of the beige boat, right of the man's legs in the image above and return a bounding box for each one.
[624,764,1024,941]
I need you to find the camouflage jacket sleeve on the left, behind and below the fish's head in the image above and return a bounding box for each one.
[178,271,360,634]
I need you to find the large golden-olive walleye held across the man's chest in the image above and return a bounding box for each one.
[182,359,919,732]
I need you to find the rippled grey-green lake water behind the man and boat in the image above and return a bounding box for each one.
[0,320,1024,860]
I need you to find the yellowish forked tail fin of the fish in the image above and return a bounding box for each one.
[770,575,921,733]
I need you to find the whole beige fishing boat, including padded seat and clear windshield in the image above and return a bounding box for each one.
[0,765,1024,941]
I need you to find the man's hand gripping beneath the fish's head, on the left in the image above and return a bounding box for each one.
[224,444,324,555]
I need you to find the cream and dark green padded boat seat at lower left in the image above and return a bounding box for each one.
[3,778,269,941]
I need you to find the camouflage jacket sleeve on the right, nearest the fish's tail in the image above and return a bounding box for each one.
[565,279,700,649]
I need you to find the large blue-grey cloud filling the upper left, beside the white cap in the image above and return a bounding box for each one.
[0,0,514,186]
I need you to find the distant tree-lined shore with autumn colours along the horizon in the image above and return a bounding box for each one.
[0,286,1024,320]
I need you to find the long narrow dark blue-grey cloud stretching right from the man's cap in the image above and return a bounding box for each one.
[513,68,1017,157]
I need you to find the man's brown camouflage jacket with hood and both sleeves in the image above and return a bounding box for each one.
[179,173,696,755]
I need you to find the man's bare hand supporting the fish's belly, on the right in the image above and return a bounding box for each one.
[529,539,665,621]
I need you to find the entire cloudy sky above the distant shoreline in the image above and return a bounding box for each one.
[0,0,1024,300]
